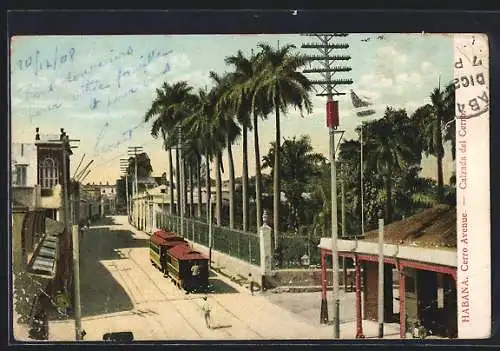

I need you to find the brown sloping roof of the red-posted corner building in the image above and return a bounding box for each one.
[364,205,457,248]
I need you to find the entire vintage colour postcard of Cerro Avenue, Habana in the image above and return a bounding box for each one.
[9,33,491,342]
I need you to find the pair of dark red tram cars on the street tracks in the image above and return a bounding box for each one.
[149,230,209,292]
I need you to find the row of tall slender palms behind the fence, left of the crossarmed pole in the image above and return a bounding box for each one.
[144,43,312,249]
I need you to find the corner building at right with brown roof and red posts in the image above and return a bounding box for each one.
[319,205,457,338]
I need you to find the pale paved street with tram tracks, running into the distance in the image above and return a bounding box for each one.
[49,216,398,341]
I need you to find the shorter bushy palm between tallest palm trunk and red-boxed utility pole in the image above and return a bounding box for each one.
[262,135,326,233]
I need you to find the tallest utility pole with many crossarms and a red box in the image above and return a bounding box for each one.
[302,33,352,339]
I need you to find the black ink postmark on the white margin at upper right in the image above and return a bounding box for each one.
[452,36,490,119]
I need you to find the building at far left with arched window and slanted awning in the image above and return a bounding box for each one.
[11,128,79,339]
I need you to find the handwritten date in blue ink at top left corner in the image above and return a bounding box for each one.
[17,46,76,75]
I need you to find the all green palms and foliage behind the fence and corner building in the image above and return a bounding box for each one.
[140,43,456,266]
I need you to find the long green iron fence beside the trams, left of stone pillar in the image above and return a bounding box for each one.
[160,215,260,266]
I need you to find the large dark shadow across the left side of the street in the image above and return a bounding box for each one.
[80,223,149,317]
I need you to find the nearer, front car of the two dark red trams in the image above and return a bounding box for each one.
[166,243,209,292]
